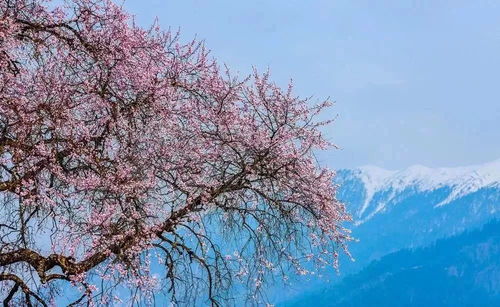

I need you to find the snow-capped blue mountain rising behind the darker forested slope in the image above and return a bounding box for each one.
[336,159,500,265]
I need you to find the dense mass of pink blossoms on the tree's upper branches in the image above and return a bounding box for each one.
[0,0,349,304]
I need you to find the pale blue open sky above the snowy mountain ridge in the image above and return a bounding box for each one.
[125,0,500,169]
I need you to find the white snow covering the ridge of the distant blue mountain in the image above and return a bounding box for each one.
[340,159,500,224]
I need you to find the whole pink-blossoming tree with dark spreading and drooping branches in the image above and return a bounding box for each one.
[0,0,350,306]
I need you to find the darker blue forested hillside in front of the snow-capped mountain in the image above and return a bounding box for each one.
[280,220,500,307]
